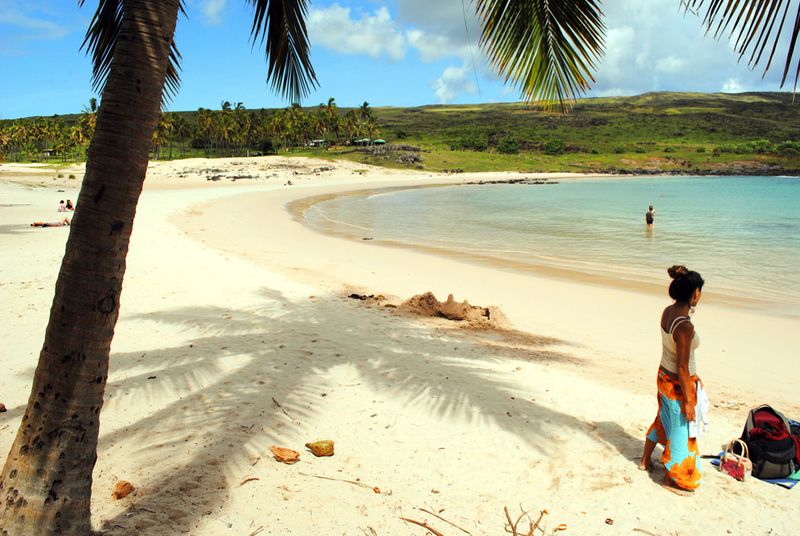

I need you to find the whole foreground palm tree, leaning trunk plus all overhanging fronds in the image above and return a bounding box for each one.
[0,0,800,536]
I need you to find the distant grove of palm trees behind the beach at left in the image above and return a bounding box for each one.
[0,98,379,162]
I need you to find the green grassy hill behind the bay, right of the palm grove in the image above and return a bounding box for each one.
[336,93,800,173]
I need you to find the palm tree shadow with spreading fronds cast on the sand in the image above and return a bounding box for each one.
[87,291,628,535]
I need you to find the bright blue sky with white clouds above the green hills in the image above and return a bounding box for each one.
[0,0,791,119]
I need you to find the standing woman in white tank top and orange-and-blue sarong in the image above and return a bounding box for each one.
[639,266,704,495]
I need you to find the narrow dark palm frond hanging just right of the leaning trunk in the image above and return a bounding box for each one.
[248,0,317,102]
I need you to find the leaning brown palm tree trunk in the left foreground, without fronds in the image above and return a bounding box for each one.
[0,0,178,536]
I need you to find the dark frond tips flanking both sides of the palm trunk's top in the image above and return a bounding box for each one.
[78,0,186,100]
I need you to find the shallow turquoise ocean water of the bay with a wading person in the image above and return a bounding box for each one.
[305,177,800,315]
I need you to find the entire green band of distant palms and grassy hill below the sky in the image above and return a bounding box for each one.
[6,93,800,174]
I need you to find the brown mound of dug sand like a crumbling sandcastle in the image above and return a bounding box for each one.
[398,292,509,329]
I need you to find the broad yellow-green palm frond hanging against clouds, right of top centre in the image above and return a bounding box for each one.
[477,0,605,111]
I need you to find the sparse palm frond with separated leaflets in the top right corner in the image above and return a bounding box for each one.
[681,0,800,91]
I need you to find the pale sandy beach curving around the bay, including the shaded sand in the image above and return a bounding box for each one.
[0,157,800,536]
